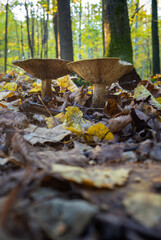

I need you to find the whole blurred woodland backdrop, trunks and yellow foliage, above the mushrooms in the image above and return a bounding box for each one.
[0,0,161,78]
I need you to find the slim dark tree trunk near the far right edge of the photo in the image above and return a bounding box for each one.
[152,0,160,75]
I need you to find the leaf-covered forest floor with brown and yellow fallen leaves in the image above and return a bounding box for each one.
[0,72,161,240]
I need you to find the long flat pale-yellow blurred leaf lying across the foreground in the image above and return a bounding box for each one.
[51,164,130,189]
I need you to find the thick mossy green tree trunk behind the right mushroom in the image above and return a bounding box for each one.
[103,0,133,63]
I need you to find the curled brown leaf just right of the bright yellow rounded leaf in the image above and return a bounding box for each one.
[108,114,132,133]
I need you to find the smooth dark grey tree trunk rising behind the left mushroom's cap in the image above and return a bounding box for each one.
[58,0,73,61]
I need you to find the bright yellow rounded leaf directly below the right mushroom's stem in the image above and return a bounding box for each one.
[85,123,113,142]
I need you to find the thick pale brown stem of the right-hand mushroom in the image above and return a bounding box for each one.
[92,83,106,107]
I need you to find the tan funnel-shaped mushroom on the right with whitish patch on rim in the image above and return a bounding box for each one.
[67,58,133,107]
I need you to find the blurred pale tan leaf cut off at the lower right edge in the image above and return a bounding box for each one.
[124,192,161,228]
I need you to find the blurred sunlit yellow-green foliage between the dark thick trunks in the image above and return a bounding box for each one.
[0,0,161,79]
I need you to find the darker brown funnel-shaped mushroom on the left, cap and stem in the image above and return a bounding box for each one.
[12,58,70,97]
